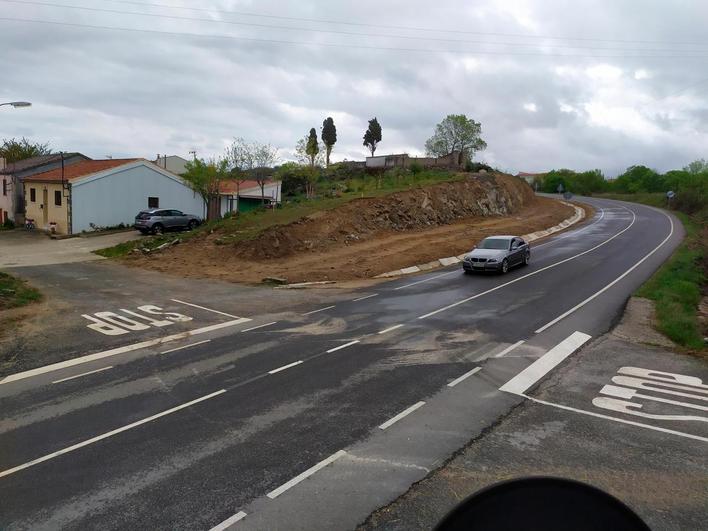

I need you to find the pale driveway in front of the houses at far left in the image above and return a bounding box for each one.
[0,229,141,269]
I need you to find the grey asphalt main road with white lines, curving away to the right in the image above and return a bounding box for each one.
[0,199,696,529]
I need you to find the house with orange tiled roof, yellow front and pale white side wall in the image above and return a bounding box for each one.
[23,159,205,234]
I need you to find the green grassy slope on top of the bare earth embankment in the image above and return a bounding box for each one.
[94,170,467,258]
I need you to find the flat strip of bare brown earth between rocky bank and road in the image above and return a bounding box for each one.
[125,198,573,282]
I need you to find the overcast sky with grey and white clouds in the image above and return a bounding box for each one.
[0,0,708,176]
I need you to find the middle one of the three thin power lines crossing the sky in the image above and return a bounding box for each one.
[0,0,708,54]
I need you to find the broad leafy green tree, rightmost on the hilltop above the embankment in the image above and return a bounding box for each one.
[425,114,487,163]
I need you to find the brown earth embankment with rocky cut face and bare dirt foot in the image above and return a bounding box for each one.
[126,174,573,282]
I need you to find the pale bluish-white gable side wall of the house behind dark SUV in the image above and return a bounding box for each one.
[72,162,204,233]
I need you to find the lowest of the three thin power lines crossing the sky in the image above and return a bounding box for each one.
[0,17,708,59]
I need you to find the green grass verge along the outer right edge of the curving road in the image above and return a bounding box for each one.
[598,193,708,350]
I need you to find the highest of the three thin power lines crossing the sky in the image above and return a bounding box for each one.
[91,0,708,46]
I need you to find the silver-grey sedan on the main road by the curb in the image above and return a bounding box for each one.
[462,236,531,273]
